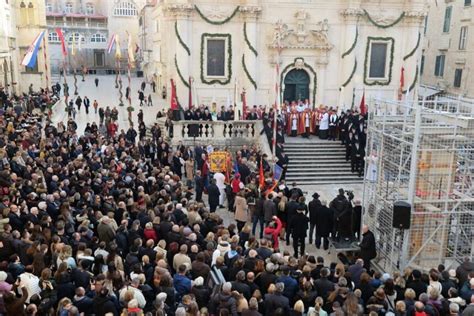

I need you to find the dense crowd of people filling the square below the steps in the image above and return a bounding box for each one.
[0,84,474,316]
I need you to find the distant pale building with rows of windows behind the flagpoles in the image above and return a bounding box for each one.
[45,0,145,74]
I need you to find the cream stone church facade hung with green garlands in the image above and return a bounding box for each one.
[142,0,428,109]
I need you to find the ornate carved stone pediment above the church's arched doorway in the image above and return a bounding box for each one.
[269,10,332,51]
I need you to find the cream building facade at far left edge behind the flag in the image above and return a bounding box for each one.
[0,0,51,94]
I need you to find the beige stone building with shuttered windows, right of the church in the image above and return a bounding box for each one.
[421,0,474,99]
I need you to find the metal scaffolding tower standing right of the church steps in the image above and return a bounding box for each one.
[363,99,474,271]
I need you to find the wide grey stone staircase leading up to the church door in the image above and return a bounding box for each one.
[284,136,363,185]
